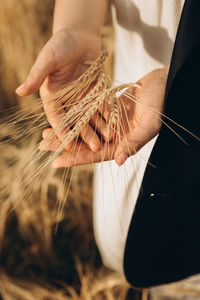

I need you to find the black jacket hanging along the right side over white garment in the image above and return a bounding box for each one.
[124,0,200,287]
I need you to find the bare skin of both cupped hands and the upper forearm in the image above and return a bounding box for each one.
[16,0,168,168]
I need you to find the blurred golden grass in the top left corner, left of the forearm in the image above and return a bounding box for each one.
[0,0,53,107]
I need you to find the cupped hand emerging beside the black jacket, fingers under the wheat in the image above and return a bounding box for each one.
[41,67,168,168]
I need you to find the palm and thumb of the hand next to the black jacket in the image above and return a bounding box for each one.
[114,66,169,165]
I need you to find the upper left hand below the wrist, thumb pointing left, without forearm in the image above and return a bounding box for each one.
[16,28,104,151]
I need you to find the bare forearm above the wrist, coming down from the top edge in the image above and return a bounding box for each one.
[53,0,109,34]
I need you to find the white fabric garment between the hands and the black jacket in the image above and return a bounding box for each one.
[93,0,184,273]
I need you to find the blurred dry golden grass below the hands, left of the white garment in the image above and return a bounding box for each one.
[0,123,130,300]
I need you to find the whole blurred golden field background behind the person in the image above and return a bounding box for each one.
[0,0,200,300]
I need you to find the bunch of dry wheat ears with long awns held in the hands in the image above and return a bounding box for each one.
[0,51,199,238]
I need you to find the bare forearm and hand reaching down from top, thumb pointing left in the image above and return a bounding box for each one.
[16,0,109,151]
